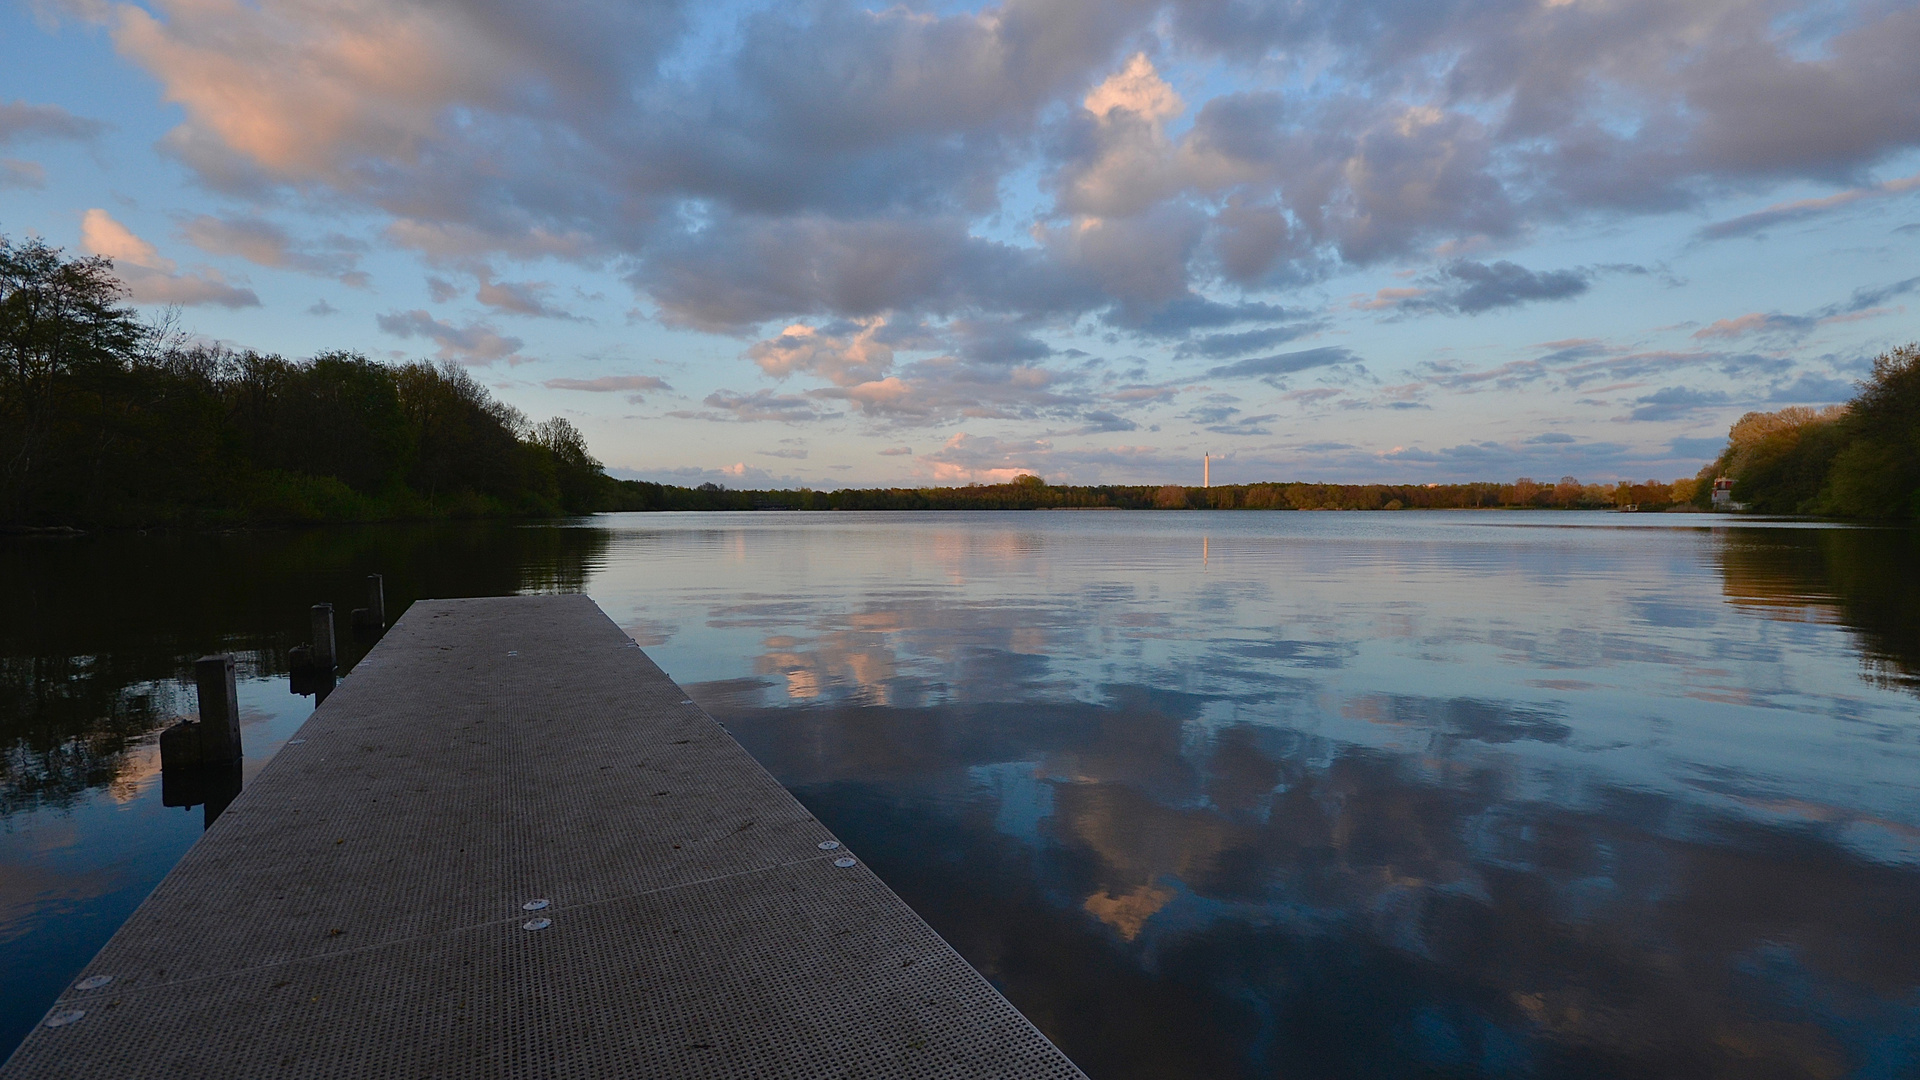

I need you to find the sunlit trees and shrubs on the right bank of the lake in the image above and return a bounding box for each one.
[1693,344,1920,521]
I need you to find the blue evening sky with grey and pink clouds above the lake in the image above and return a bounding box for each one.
[0,0,1920,488]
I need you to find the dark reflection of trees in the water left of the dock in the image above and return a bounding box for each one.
[0,525,607,813]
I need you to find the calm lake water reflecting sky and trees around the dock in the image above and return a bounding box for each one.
[0,511,1920,1080]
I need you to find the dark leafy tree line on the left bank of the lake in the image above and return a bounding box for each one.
[0,236,612,527]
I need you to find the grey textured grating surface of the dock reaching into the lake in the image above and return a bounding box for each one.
[0,596,1081,1080]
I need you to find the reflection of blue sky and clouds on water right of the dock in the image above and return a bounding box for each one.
[591,515,1920,1078]
